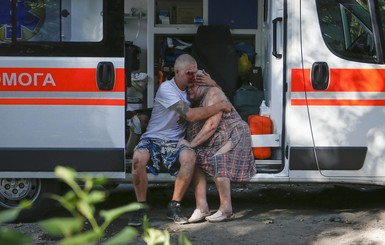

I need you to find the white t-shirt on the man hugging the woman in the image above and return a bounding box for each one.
[142,79,190,140]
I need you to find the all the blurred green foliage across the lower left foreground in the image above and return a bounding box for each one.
[0,166,191,245]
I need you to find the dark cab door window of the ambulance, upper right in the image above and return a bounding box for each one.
[317,0,377,63]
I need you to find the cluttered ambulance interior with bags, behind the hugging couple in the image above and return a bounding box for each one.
[125,0,284,173]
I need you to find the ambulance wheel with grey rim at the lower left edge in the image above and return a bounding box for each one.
[0,178,58,222]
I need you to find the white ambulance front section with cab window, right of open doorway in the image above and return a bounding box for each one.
[290,0,385,180]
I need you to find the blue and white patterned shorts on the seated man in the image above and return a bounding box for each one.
[134,137,194,176]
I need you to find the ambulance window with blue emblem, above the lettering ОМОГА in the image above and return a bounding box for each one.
[0,0,103,43]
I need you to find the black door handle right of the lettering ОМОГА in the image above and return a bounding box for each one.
[96,61,115,90]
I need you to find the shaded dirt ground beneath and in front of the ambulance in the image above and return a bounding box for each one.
[4,184,385,245]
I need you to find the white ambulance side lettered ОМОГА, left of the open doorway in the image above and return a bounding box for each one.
[0,0,125,218]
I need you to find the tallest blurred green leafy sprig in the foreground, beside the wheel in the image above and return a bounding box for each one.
[39,166,143,245]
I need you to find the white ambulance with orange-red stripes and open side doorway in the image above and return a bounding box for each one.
[0,0,385,219]
